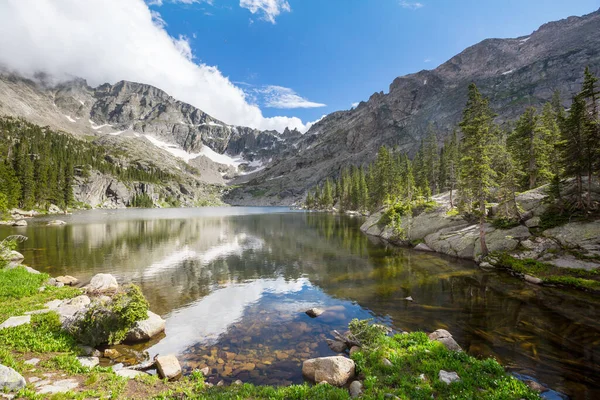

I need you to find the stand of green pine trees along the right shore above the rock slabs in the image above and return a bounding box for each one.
[305,68,600,255]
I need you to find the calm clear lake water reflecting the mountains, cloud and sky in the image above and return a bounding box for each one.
[0,208,600,398]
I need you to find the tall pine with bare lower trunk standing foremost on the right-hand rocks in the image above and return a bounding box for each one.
[460,83,495,256]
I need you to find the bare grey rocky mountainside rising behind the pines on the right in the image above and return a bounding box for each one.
[224,11,600,204]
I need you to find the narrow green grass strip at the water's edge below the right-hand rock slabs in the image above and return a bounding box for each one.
[494,253,600,291]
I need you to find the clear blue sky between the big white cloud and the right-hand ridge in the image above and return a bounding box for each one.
[148,0,600,122]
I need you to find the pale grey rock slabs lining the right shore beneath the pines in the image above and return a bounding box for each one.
[360,185,600,290]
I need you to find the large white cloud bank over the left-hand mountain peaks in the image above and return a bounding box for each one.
[0,0,306,131]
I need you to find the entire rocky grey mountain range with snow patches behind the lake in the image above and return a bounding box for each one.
[0,10,600,205]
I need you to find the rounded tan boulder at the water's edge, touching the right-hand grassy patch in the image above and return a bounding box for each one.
[302,356,355,387]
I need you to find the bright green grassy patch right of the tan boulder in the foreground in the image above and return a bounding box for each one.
[351,327,539,400]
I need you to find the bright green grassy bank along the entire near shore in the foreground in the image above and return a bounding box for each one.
[0,267,538,400]
